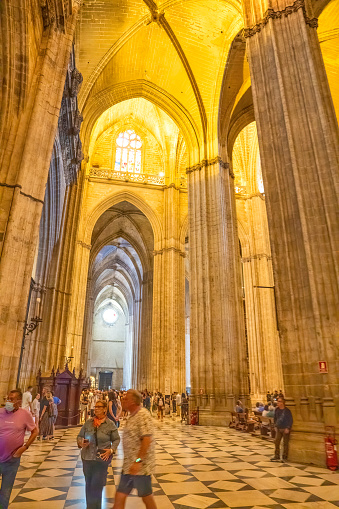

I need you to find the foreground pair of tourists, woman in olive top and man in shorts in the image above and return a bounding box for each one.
[77,390,156,509]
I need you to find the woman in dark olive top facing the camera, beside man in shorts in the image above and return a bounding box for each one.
[77,400,120,509]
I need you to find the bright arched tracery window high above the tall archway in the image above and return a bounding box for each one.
[114,129,142,173]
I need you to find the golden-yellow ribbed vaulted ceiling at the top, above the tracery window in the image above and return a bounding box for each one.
[76,0,242,153]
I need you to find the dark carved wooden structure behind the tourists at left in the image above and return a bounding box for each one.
[37,364,89,427]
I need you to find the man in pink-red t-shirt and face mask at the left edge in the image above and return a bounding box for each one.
[0,389,38,509]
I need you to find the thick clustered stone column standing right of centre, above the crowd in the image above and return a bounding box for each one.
[187,157,249,425]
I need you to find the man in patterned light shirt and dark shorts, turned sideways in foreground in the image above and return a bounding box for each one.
[113,389,156,509]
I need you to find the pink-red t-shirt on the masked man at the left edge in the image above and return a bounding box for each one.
[0,408,35,463]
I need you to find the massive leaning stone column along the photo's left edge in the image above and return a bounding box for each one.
[0,3,78,394]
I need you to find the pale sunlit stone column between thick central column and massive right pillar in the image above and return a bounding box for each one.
[242,193,283,403]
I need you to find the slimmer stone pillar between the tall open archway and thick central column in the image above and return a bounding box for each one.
[152,185,185,392]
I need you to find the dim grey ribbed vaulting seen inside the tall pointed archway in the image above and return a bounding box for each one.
[90,202,154,314]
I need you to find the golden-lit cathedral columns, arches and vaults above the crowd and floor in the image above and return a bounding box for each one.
[0,0,339,476]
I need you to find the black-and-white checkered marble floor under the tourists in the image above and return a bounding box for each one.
[10,419,339,509]
